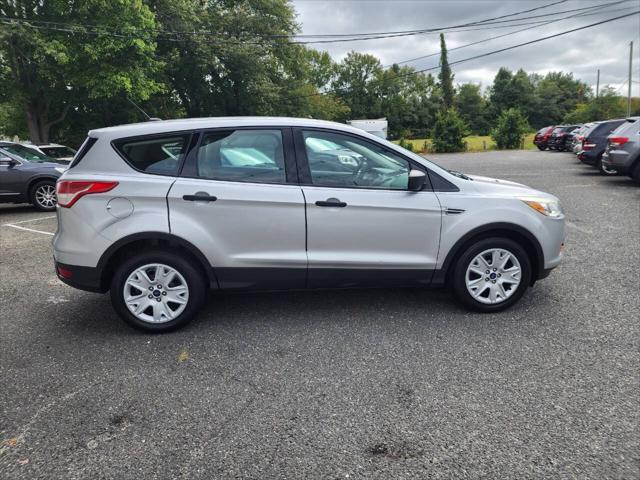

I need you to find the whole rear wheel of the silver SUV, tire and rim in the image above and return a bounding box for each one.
[111,250,206,332]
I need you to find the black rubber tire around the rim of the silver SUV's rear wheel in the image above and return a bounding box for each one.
[111,250,207,333]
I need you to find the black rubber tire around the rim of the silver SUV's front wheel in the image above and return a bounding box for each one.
[451,237,532,312]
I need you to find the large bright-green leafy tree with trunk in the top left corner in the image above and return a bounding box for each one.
[0,0,162,143]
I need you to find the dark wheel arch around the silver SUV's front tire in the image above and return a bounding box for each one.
[432,222,544,285]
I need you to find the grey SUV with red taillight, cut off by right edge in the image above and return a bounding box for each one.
[602,117,640,183]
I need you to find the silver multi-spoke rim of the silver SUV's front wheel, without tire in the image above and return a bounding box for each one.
[465,248,522,305]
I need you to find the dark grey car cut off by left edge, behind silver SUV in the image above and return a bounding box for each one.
[0,142,67,211]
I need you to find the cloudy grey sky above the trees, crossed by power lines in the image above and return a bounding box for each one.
[293,0,640,95]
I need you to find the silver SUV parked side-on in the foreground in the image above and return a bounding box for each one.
[53,117,565,332]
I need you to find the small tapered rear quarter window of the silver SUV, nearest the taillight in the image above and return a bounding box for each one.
[114,134,190,176]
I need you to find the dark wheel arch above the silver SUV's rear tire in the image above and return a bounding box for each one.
[96,232,218,291]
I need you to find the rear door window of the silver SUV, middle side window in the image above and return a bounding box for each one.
[197,130,286,183]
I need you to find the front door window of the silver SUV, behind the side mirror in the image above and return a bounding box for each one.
[303,131,411,190]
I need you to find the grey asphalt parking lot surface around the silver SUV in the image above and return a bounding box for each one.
[0,151,640,479]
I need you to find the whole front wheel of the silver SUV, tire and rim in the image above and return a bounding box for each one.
[453,237,532,312]
